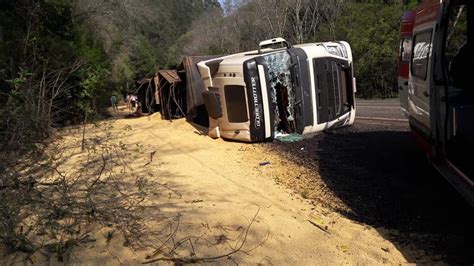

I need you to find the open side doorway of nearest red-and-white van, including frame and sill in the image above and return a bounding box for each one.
[431,1,474,206]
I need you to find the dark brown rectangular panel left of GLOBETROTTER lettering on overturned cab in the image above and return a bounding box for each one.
[224,85,249,123]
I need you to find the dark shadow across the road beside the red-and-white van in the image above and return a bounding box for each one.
[271,126,474,264]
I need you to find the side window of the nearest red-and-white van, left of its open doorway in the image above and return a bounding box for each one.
[411,30,431,79]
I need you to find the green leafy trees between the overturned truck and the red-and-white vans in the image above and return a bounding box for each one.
[318,1,404,98]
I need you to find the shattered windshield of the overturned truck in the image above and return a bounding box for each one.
[263,51,296,133]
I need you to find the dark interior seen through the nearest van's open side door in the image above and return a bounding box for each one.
[439,2,474,179]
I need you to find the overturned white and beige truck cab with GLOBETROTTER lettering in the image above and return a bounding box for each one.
[197,38,356,142]
